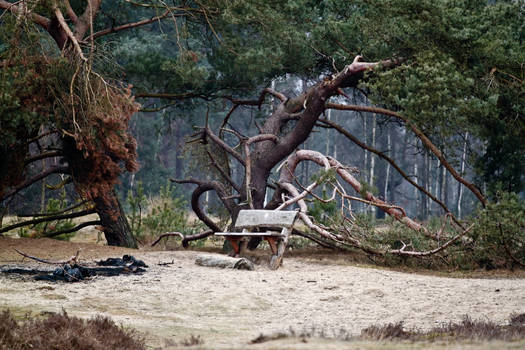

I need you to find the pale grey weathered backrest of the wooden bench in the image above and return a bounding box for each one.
[235,209,297,229]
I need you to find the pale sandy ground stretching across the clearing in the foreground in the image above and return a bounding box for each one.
[0,238,525,349]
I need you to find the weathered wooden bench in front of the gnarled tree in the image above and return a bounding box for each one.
[215,209,297,270]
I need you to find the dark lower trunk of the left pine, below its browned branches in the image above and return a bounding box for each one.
[93,191,137,248]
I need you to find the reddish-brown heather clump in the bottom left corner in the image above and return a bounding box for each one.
[0,311,145,350]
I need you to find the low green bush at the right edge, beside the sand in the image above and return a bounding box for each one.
[470,192,525,268]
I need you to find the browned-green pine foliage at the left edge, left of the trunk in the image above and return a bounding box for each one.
[0,17,69,195]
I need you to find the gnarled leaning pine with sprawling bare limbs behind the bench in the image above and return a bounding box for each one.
[164,56,486,256]
